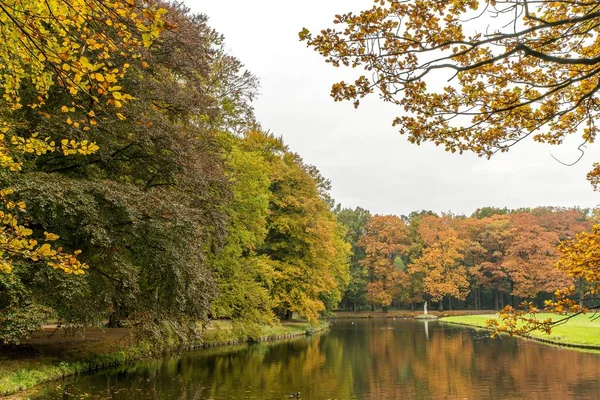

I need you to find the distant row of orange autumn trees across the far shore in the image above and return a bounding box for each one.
[336,206,597,311]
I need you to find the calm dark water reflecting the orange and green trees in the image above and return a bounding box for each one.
[38,319,600,400]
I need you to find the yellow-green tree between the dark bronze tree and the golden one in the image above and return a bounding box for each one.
[211,133,275,336]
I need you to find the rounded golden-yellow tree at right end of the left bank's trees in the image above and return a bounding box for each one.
[245,130,350,322]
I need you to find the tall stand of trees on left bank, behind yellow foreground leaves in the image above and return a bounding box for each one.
[0,3,349,342]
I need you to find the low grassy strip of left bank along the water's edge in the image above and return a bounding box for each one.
[0,321,329,400]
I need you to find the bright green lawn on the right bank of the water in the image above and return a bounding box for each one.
[440,313,600,351]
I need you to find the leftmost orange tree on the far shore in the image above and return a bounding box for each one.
[358,215,408,309]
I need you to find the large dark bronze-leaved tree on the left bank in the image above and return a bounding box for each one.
[0,6,243,341]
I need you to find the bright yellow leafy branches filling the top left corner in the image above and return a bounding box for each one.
[0,0,166,113]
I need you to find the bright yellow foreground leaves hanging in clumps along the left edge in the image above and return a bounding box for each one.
[0,0,168,274]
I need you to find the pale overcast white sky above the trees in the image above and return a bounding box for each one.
[190,0,600,215]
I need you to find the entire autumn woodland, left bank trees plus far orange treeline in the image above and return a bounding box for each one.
[0,0,597,343]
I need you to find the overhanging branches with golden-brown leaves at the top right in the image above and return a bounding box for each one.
[300,0,600,186]
